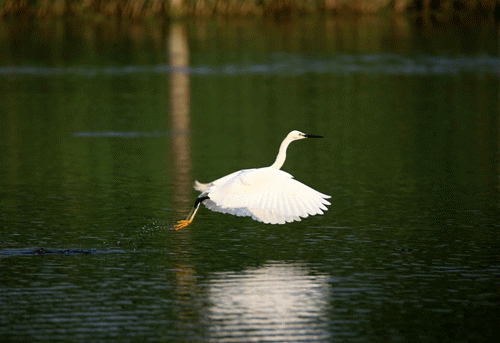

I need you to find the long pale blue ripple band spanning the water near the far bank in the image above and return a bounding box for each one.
[0,54,500,77]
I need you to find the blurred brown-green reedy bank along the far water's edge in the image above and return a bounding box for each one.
[0,0,500,20]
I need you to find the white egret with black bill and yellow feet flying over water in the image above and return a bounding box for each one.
[172,130,330,230]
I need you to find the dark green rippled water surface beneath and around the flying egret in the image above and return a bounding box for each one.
[0,17,500,342]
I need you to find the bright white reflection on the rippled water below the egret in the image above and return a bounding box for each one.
[208,264,329,342]
